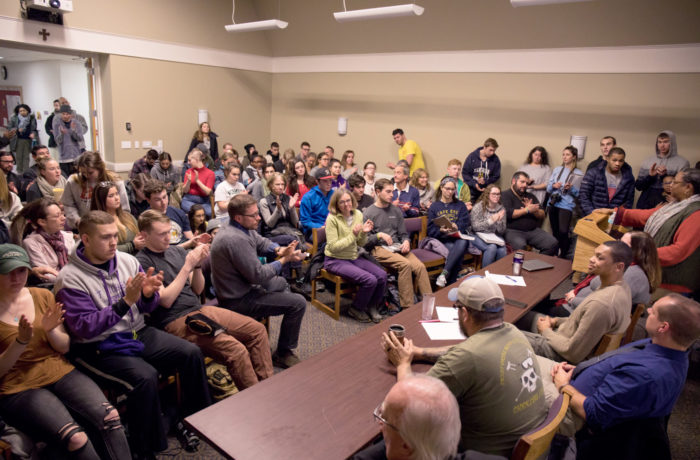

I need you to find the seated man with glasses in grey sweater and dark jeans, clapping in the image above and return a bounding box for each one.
[211,194,306,368]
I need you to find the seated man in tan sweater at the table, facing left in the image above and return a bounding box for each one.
[519,241,632,364]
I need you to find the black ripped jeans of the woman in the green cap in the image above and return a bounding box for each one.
[0,370,131,459]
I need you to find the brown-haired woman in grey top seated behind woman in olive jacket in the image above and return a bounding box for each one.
[61,151,131,228]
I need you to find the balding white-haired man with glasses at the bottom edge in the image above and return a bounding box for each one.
[353,375,470,460]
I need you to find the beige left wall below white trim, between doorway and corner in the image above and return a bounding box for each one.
[101,55,272,163]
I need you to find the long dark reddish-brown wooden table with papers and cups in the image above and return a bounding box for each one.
[186,253,571,460]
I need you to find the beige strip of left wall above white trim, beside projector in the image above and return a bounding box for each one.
[0,0,271,56]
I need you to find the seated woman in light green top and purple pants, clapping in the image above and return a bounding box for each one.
[323,187,386,323]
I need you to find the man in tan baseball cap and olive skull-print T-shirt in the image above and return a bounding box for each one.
[382,276,547,457]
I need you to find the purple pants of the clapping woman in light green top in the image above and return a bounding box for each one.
[323,257,386,312]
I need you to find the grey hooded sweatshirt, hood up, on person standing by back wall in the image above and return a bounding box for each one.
[634,130,690,209]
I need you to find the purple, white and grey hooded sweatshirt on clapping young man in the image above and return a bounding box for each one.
[54,244,160,343]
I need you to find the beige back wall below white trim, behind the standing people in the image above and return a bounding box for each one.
[271,74,700,183]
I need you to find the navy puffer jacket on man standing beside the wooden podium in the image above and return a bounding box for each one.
[578,161,634,216]
